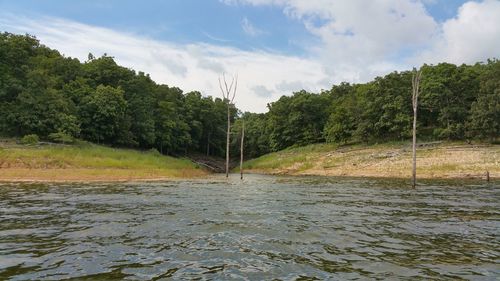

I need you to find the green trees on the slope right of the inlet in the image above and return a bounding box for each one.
[236,59,500,157]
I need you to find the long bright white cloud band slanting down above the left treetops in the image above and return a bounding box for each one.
[0,16,330,112]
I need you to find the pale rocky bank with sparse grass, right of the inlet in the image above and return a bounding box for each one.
[244,143,500,178]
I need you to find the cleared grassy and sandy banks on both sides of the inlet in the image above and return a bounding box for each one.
[0,140,500,182]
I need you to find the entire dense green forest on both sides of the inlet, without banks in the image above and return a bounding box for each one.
[0,33,500,157]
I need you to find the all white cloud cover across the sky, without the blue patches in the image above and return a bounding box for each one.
[0,0,500,112]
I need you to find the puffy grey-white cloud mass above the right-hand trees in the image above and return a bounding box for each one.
[221,0,500,75]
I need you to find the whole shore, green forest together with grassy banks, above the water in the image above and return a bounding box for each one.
[0,32,500,181]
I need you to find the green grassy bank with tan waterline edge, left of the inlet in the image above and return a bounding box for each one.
[0,141,206,181]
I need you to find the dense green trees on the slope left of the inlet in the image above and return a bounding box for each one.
[0,33,236,156]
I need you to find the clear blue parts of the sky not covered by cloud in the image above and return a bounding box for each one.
[0,0,466,55]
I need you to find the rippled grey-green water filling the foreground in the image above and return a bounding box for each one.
[0,175,500,280]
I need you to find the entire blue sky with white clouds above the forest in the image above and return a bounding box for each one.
[0,0,500,112]
